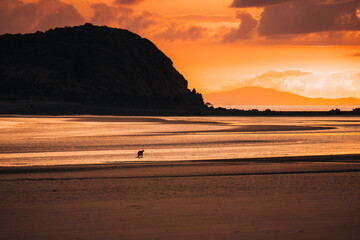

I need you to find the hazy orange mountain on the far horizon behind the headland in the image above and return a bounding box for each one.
[203,87,360,106]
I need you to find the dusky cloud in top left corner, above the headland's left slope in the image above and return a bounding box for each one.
[0,0,85,34]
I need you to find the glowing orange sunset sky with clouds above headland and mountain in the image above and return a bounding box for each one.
[0,0,360,98]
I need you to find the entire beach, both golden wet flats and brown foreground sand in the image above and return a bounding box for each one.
[0,116,360,239]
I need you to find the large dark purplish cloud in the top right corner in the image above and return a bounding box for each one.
[259,0,360,36]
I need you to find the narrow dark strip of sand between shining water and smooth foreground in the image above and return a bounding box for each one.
[0,154,360,182]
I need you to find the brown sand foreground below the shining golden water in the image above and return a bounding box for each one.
[0,159,360,240]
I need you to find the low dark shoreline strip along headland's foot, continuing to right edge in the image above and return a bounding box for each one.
[0,100,360,117]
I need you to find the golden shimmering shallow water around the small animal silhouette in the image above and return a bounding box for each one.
[0,116,360,166]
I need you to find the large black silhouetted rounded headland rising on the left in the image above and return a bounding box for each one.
[0,23,205,114]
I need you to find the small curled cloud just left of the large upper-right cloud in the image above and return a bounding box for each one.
[224,12,258,42]
